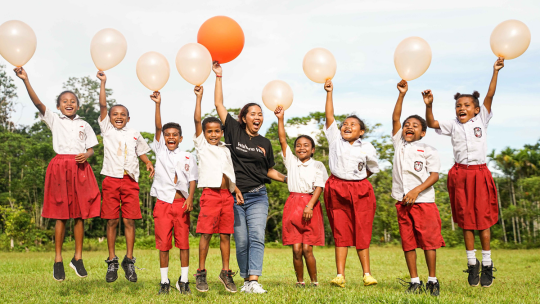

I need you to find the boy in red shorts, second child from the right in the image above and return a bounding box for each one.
[392,80,445,296]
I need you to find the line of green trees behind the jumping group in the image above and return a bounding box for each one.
[0,65,540,251]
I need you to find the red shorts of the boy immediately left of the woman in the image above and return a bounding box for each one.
[196,188,234,234]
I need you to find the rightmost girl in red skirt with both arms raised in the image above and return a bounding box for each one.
[422,58,504,287]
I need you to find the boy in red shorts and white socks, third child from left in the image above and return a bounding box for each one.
[150,92,198,294]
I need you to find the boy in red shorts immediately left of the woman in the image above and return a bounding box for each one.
[193,86,238,293]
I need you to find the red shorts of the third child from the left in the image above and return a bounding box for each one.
[153,198,189,251]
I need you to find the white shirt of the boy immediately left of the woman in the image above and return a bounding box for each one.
[193,132,236,192]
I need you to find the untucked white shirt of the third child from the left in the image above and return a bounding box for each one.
[150,136,199,204]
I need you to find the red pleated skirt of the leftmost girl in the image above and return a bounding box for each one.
[41,154,101,220]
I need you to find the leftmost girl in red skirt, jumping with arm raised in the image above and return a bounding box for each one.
[14,67,101,281]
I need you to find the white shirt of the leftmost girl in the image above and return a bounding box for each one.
[39,107,98,154]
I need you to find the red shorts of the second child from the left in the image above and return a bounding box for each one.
[101,174,142,220]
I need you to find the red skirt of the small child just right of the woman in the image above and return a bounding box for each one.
[282,192,324,246]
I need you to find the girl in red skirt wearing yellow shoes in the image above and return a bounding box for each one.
[324,80,379,287]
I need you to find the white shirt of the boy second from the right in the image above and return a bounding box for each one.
[392,129,441,203]
